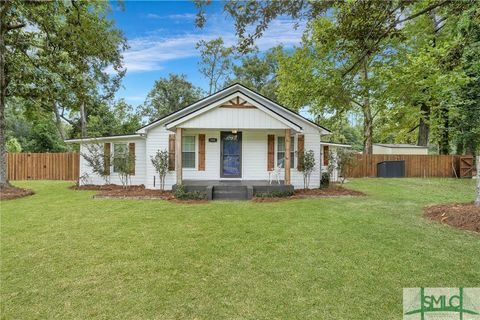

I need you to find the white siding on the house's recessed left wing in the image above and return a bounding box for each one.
[80,138,145,185]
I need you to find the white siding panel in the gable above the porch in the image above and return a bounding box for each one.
[179,107,288,129]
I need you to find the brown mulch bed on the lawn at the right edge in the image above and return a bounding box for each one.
[425,203,480,233]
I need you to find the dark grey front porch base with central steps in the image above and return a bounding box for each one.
[173,180,294,200]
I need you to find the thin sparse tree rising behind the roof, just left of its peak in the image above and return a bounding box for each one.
[196,38,233,94]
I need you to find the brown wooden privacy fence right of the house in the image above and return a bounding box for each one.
[347,154,473,178]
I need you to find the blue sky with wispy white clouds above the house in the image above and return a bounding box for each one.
[109,1,303,106]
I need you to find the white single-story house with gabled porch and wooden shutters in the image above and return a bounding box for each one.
[68,84,344,199]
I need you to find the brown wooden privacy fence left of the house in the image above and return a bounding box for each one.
[7,153,80,180]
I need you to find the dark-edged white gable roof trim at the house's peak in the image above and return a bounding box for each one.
[137,83,330,134]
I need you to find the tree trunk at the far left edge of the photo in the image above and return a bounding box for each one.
[0,17,10,188]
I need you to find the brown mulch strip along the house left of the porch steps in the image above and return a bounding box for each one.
[70,184,173,200]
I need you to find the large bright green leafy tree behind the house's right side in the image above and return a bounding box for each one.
[196,0,464,153]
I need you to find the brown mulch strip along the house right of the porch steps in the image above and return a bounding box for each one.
[253,185,366,202]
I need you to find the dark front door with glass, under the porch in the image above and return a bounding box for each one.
[220,132,242,178]
